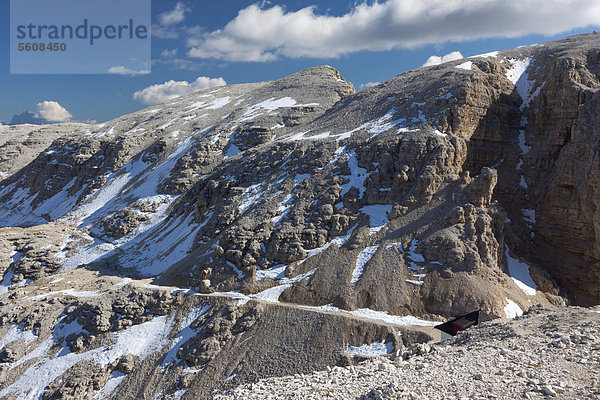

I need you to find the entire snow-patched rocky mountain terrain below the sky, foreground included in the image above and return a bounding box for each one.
[0,33,600,399]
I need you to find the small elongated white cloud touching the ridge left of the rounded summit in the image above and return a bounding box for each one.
[133,76,227,104]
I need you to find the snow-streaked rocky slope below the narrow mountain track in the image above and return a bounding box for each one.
[0,269,433,399]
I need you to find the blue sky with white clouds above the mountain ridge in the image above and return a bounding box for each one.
[0,0,600,122]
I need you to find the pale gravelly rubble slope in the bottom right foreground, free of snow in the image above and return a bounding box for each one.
[212,307,600,400]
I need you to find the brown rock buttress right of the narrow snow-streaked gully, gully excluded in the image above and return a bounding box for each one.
[524,40,600,305]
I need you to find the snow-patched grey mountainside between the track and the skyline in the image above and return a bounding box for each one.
[0,35,600,315]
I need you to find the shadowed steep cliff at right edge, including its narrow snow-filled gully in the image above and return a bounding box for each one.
[478,35,600,305]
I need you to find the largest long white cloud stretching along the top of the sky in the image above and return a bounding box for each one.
[188,0,600,61]
